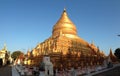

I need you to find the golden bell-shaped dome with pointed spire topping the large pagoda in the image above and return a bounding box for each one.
[52,9,77,36]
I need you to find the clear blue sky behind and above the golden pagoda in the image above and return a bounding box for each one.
[0,0,120,54]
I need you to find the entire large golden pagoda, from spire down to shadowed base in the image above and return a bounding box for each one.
[26,9,104,68]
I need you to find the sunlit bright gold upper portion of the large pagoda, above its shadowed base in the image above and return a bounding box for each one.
[32,9,102,56]
